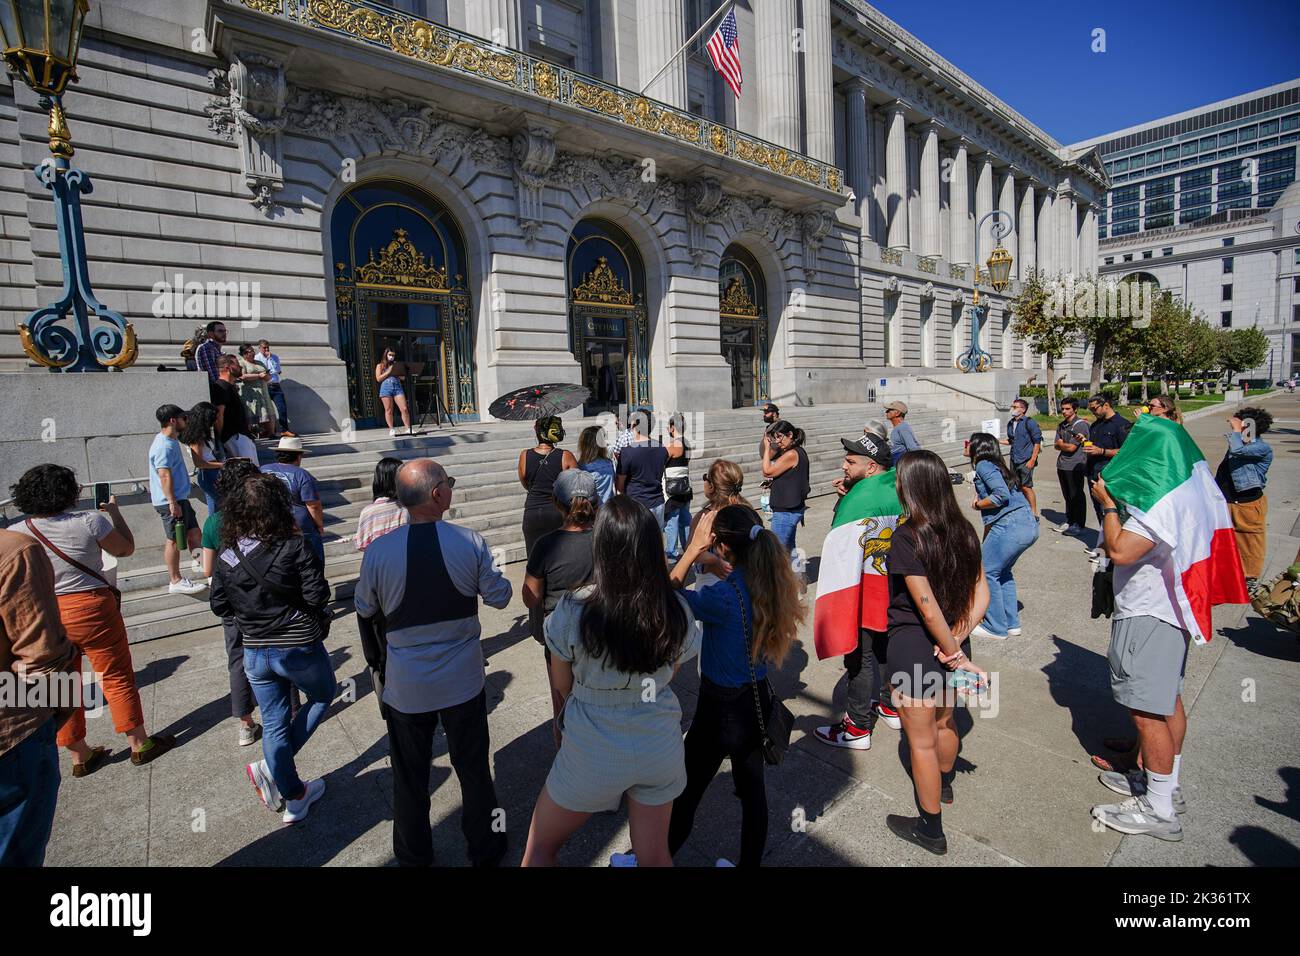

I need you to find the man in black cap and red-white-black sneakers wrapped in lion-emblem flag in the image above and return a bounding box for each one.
[813,427,902,750]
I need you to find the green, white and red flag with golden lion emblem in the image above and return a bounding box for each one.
[813,470,902,659]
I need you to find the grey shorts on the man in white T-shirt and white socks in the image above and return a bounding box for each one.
[1106,615,1191,717]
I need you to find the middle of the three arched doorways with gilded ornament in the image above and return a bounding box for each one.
[564,219,650,415]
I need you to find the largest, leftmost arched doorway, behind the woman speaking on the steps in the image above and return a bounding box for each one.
[330,179,478,427]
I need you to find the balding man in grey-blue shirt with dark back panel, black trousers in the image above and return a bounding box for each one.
[355,458,511,866]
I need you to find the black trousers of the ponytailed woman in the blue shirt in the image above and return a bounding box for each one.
[668,676,771,866]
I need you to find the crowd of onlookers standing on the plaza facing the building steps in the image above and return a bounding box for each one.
[0,382,1273,866]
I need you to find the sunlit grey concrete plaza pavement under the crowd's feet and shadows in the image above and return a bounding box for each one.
[47,395,1300,866]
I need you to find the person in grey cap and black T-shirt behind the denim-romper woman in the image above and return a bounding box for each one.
[524,468,599,749]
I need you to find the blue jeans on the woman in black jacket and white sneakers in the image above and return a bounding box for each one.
[244,641,338,800]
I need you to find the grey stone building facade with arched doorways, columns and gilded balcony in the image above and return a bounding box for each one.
[0,0,1106,431]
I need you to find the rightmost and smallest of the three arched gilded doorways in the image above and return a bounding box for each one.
[718,246,771,408]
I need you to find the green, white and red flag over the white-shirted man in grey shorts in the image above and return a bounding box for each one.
[1102,415,1251,644]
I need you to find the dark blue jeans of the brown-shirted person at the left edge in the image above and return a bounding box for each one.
[0,718,59,866]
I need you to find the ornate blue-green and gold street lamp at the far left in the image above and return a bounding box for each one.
[0,0,137,372]
